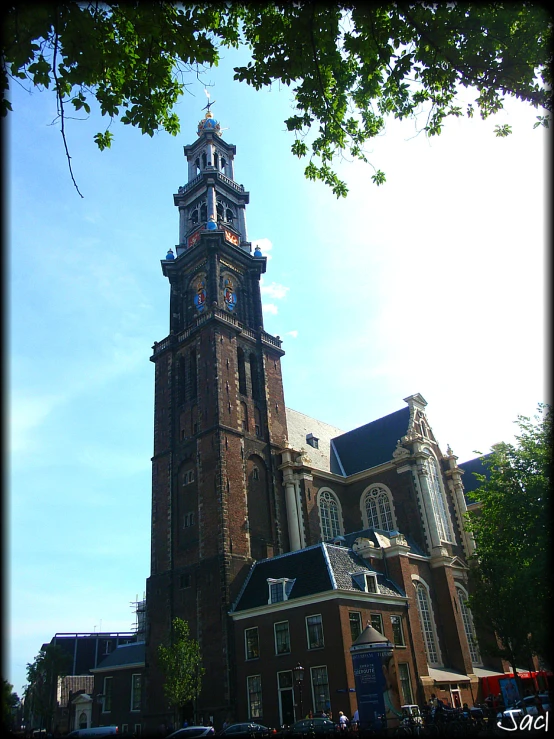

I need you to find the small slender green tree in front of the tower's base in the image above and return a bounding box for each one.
[158,618,204,714]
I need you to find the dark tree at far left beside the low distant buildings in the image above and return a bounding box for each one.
[25,644,70,729]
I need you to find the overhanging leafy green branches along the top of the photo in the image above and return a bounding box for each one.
[1,1,552,196]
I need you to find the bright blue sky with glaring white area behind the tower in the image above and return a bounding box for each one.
[3,43,550,695]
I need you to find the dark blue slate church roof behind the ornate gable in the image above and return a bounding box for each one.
[331,407,410,475]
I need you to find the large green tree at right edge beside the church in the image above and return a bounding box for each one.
[469,405,552,670]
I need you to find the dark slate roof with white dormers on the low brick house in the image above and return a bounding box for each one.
[231,542,404,613]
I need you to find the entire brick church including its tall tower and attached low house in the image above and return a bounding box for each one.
[144,105,532,729]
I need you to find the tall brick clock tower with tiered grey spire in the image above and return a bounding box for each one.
[144,104,290,728]
